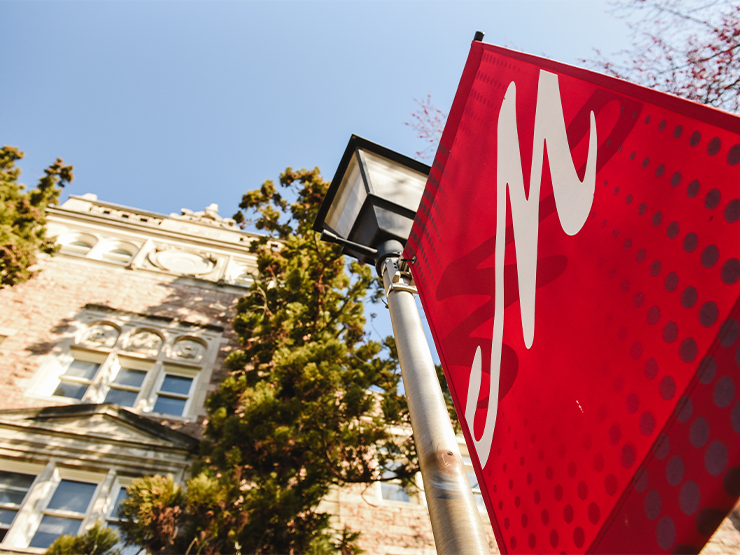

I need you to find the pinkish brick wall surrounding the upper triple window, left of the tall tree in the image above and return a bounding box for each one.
[0,255,240,435]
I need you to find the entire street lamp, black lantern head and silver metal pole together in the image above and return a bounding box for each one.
[314,135,490,555]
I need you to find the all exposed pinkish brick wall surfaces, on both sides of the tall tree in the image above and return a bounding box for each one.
[0,255,740,555]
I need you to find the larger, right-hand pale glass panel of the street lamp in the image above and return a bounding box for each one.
[360,150,427,212]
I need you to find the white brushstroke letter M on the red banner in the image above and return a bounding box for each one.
[465,70,597,468]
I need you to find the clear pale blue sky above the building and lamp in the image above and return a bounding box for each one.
[0,0,629,352]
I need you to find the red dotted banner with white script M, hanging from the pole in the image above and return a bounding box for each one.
[405,42,740,553]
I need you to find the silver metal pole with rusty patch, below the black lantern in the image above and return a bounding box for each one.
[382,256,491,555]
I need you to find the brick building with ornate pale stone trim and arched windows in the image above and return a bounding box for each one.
[0,195,740,555]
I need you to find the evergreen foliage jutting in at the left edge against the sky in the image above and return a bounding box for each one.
[0,146,73,289]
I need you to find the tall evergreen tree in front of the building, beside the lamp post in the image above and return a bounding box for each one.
[121,168,418,554]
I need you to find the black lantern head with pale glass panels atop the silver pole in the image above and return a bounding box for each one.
[313,135,430,265]
